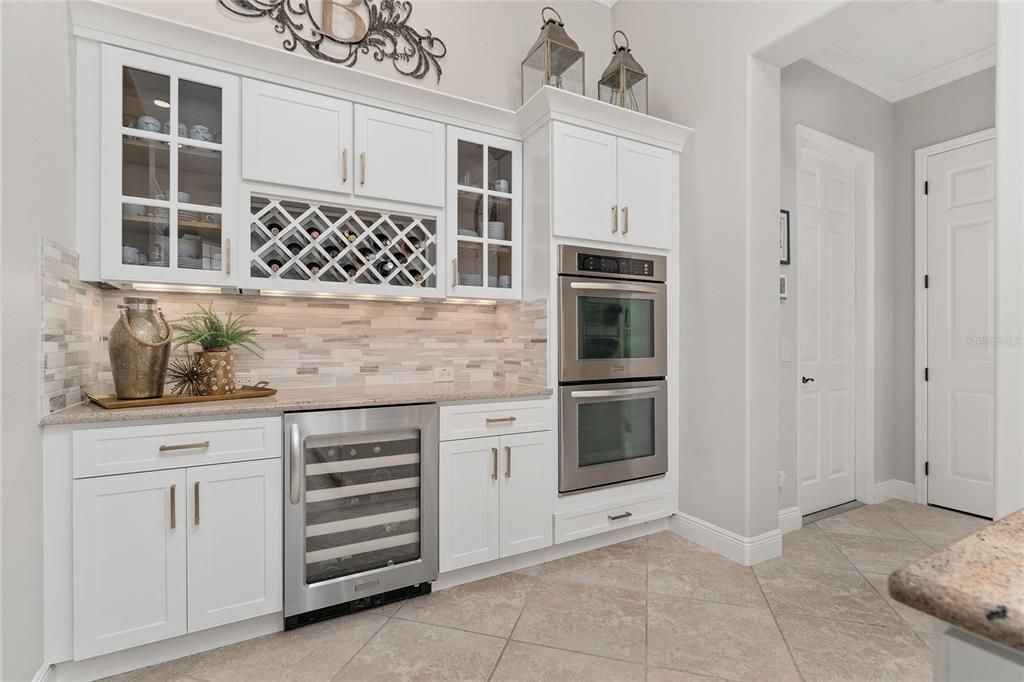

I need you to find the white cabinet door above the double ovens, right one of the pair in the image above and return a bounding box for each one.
[618,139,679,249]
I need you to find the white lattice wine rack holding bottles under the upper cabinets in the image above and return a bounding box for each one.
[250,195,437,291]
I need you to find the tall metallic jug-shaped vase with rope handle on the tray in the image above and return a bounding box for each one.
[108,297,171,400]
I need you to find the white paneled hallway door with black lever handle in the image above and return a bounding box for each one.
[797,147,856,514]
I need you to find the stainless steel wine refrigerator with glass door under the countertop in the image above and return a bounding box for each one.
[285,404,438,629]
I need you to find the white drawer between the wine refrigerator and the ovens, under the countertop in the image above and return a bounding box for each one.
[440,400,553,440]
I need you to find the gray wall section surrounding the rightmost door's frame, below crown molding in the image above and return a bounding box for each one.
[893,69,995,481]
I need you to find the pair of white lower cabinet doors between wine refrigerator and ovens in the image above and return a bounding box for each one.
[439,431,555,572]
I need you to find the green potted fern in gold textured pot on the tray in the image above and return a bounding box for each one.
[171,303,263,395]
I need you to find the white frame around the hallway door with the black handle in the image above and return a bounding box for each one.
[791,124,876,508]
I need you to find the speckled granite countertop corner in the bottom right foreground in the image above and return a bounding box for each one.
[889,510,1024,651]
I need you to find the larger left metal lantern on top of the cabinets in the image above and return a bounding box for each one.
[522,7,585,102]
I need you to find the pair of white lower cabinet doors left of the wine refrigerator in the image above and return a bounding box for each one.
[74,459,282,660]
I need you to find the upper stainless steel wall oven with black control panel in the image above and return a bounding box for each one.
[558,245,668,382]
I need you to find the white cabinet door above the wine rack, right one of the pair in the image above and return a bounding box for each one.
[355,104,444,206]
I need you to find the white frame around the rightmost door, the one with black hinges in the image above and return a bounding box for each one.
[913,128,998,504]
